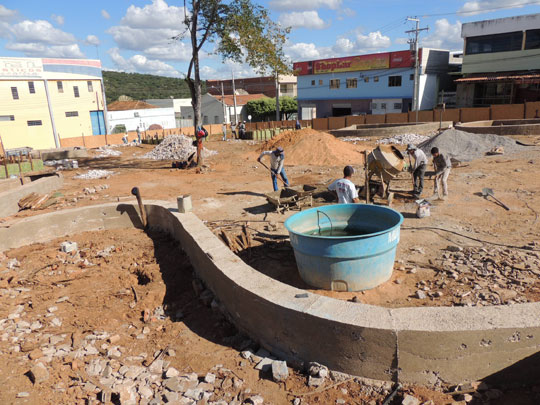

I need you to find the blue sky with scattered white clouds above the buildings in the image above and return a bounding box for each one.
[0,0,540,79]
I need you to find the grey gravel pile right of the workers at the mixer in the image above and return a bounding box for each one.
[418,129,525,162]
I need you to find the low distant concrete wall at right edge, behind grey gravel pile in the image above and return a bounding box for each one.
[456,119,540,135]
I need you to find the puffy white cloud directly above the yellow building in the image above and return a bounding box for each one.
[10,20,77,45]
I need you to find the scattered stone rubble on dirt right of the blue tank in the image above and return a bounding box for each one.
[415,241,540,306]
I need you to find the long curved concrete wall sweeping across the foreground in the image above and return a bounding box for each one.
[0,202,540,384]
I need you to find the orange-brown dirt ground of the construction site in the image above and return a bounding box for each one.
[0,131,540,404]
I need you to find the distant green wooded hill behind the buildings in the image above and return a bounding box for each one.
[103,71,206,103]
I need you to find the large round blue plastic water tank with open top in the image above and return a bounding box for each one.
[285,204,403,291]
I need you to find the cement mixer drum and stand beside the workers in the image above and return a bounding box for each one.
[367,145,405,198]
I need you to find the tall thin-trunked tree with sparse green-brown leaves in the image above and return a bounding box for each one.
[175,0,290,136]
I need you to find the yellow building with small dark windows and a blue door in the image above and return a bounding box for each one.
[0,58,107,149]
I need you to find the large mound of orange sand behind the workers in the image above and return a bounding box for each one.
[260,128,364,166]
